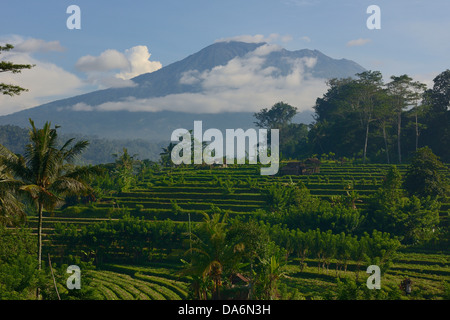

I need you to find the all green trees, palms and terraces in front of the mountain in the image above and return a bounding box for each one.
[0,48,450,300]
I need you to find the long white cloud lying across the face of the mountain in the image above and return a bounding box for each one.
[74,45,326,113]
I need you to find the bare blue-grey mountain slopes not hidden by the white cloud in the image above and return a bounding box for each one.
[0,42,364,141]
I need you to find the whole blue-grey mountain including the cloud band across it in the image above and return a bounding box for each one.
[0,41,365,139]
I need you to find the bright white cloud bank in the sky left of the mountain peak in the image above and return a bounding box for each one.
[0,39,162,115]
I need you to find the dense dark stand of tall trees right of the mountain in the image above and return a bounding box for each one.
[254,70,450,163]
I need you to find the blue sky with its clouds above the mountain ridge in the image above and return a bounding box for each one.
[0,0,450,114]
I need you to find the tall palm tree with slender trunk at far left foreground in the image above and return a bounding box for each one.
[1,119,98,297]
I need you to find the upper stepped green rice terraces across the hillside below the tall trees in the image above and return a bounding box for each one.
[30,164,450,234]
